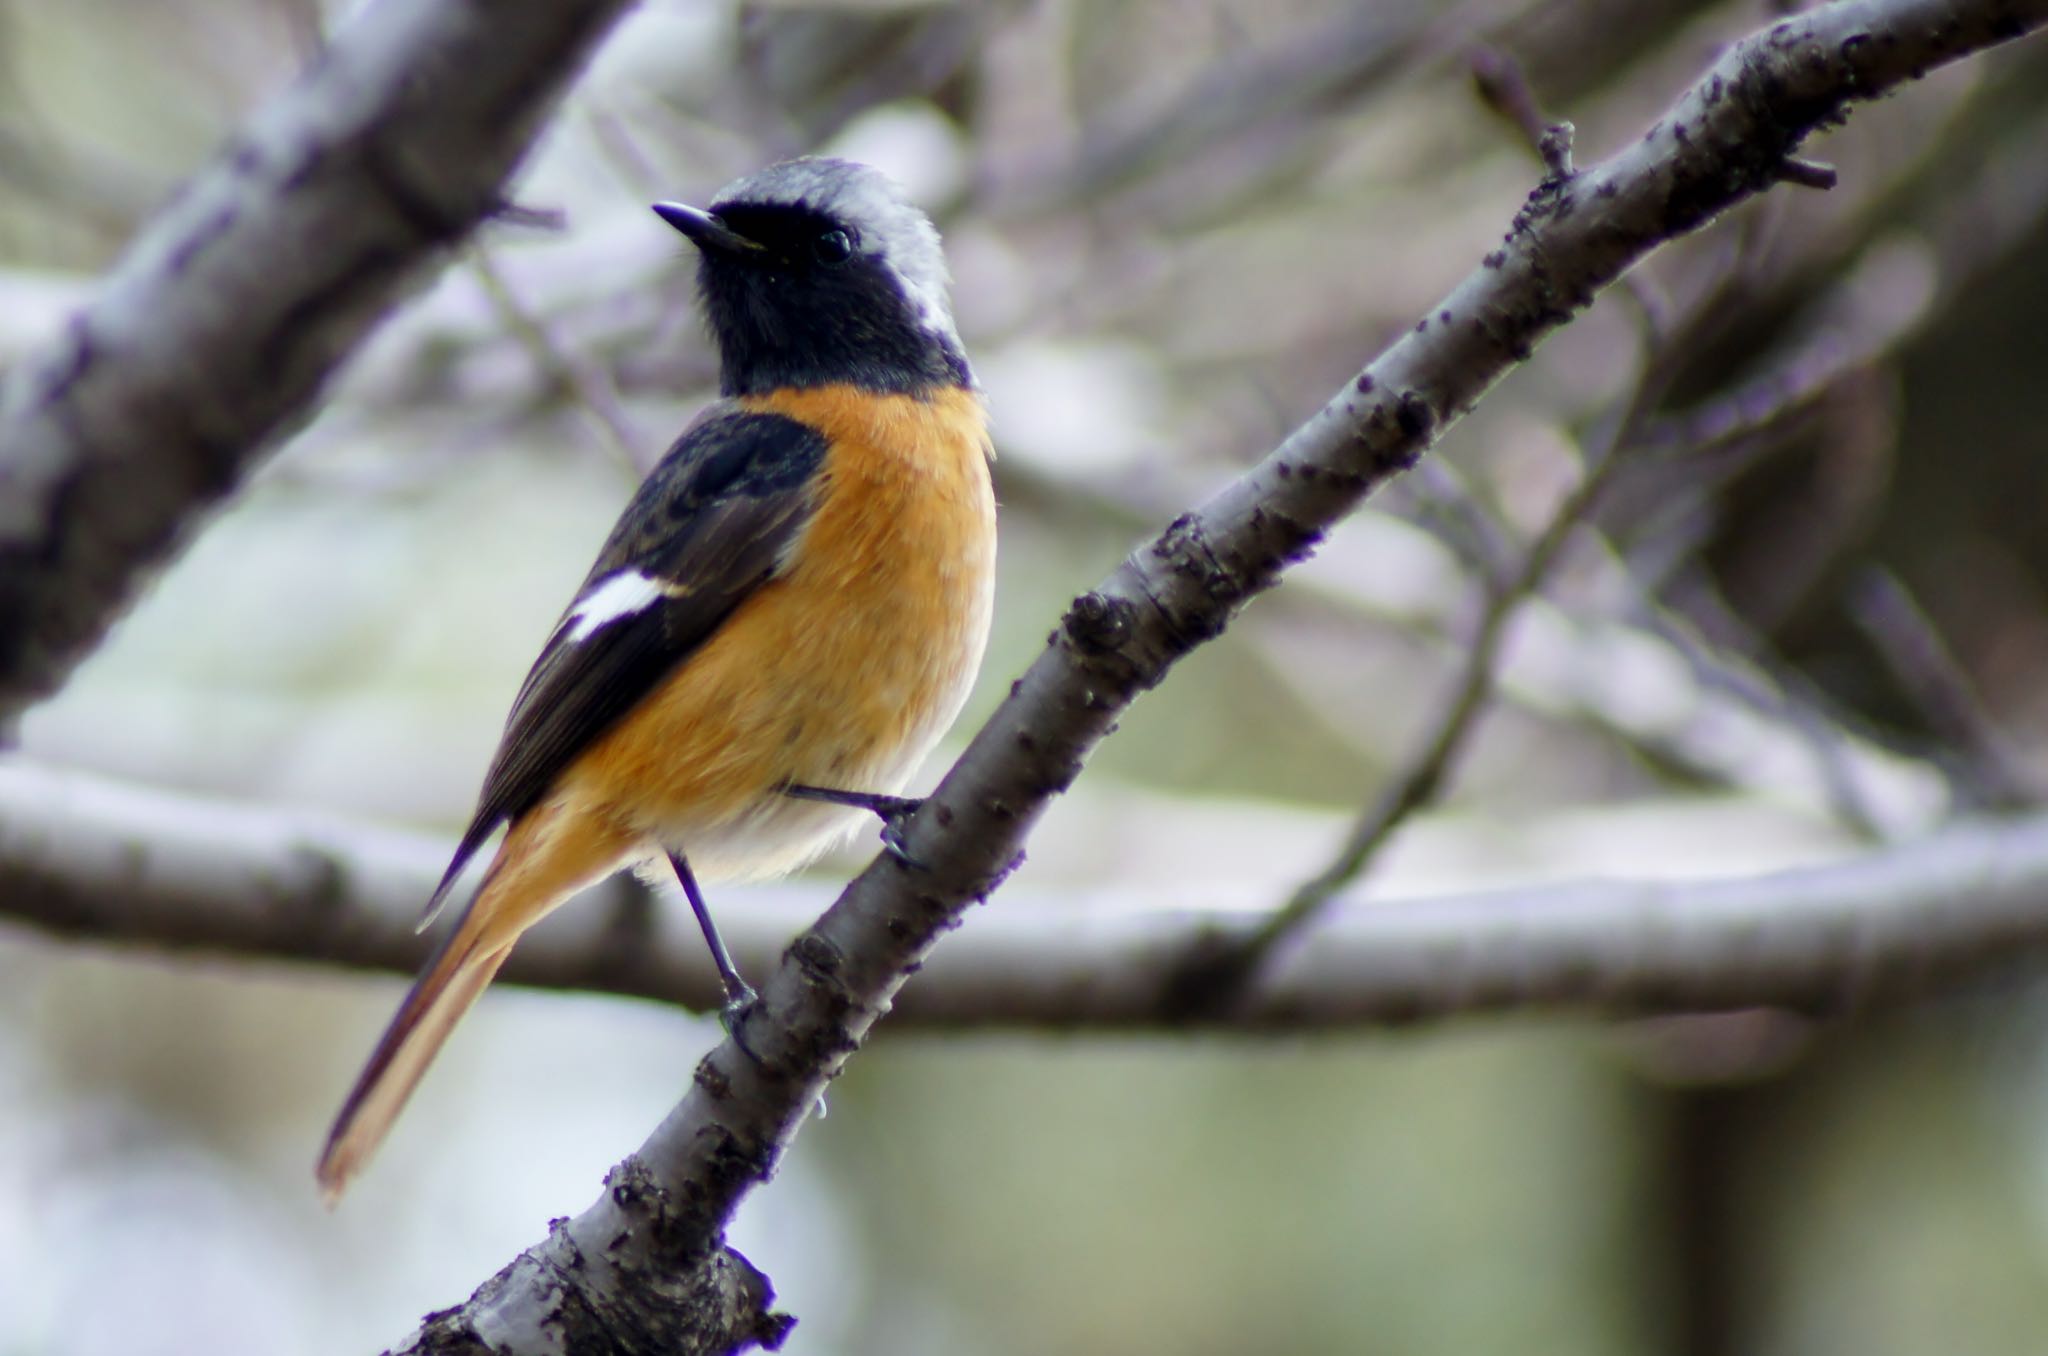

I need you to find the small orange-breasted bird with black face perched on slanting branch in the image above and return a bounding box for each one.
[317,160,995,1202]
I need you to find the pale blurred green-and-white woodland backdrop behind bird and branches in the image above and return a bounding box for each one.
[0,0,2048,1356]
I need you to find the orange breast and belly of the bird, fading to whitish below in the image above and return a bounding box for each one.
[547,387,995,879]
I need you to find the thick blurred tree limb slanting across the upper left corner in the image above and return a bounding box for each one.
[0,0,627,723]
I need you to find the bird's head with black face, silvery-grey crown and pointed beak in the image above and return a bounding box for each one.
[655,158,973,395]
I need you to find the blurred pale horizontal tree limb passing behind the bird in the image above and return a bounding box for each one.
[12,762,2048,1034]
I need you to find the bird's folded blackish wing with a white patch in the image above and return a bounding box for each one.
[428,404,825,916]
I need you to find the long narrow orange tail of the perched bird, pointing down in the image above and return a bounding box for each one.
[317,813,629,1206]
